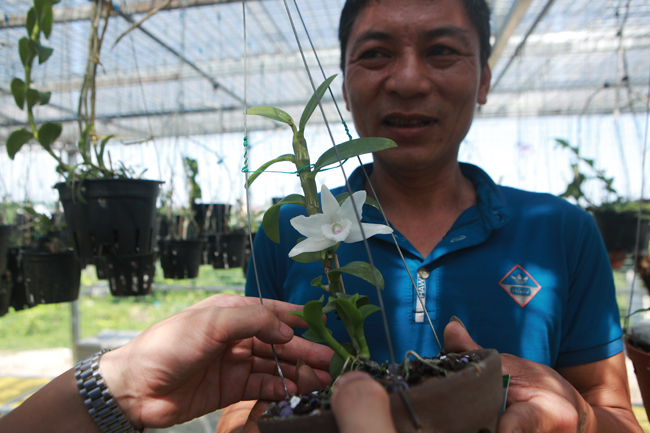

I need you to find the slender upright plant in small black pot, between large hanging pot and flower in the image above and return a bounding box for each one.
[159,157,205,279]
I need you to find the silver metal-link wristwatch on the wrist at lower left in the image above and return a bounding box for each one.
[74,349,146,433]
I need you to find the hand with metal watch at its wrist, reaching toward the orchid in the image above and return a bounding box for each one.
[100,295,332,427]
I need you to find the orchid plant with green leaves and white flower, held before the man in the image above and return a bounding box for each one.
[246,75,397,377]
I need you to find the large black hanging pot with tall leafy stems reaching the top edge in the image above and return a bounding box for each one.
[6,0,161,264]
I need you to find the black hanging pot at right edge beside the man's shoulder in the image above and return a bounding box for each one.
[592,210,650,254]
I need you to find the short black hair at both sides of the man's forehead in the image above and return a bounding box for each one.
[339,0,492,74]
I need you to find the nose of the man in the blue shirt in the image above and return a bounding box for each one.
[386,52,431,98]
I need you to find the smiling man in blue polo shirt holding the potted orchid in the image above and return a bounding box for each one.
[220,0,641,432]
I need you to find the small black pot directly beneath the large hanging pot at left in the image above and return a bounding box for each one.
[102,253,156,296]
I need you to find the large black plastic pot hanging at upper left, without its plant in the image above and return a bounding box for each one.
[54,179,162,259]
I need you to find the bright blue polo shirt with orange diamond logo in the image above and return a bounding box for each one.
[246,163,623,368]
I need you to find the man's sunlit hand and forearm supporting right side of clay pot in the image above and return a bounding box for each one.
[444,321,641,433]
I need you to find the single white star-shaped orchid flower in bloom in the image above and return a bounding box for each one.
[289,185,393,257]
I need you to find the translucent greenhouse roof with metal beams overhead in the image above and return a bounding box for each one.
[0,0,650,143]
